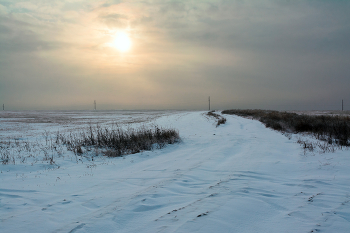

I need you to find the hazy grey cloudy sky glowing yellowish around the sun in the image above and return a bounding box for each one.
[0,0,350,110]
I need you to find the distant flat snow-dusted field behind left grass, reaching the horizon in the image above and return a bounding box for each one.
[0,111,176,139]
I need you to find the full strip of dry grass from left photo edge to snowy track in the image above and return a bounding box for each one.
[0,125,181,167]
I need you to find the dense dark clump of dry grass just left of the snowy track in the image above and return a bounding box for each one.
[56,126,180,157]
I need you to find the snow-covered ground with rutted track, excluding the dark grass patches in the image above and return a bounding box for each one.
[0,111,350,233]
